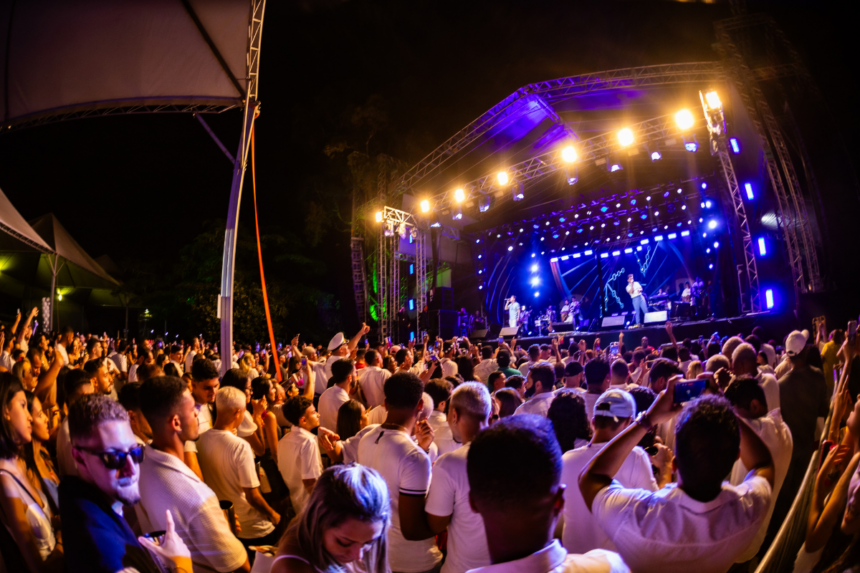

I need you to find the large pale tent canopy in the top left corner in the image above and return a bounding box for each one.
[0,0,254,129]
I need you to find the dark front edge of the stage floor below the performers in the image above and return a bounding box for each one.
[488,312,810,350]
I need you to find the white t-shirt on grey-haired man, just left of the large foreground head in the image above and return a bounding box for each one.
[424,444,490,573]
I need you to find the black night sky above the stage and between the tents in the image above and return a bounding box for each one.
[0,0,860,316]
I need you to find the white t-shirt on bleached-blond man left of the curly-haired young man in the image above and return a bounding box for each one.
[197,428,275,539]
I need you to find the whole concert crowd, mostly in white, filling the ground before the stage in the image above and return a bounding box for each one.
[0,309,860,573]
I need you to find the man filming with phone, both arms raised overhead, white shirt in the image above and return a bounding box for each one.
[579,377,774,573]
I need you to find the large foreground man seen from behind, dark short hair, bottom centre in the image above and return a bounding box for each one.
[466,416,630,573]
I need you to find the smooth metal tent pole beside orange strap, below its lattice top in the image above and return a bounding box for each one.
[218,97,257,376]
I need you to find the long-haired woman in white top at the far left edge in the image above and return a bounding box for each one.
[0,372,63,573]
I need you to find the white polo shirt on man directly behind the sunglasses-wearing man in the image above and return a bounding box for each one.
[134,446,248,573]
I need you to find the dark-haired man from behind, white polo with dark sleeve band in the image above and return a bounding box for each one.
[358,372,442,573]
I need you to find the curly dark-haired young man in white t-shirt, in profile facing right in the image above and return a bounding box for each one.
[278,396,323,514]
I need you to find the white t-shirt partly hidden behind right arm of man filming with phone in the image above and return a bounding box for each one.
[729,410,793,563]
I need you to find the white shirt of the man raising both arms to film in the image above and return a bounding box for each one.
[591,475,772,573]
